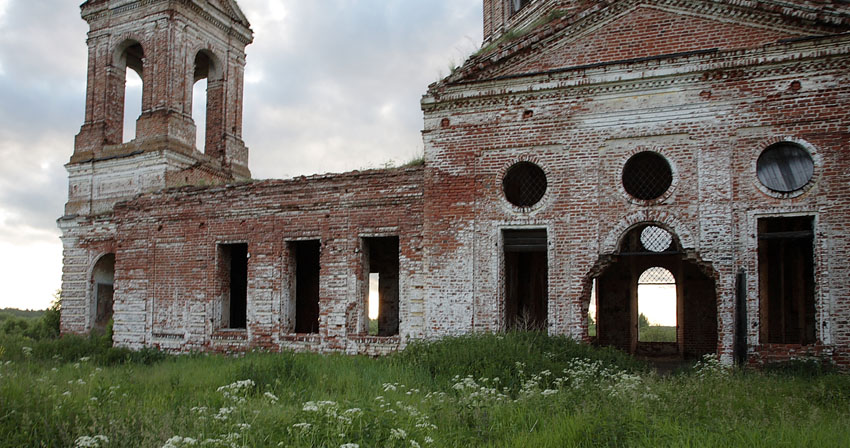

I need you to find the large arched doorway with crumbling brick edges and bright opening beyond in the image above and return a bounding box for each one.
[595,223,717,358]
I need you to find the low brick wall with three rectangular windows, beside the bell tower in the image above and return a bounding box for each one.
[115,169,424,354]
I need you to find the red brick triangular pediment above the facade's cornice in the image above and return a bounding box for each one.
[449,0,850,82]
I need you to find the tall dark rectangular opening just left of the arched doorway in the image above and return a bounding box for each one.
[502,229,549,330]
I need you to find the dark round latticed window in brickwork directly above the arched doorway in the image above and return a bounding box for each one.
[623,151,673,201]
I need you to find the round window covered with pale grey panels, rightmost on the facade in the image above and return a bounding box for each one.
[756,142,815,193]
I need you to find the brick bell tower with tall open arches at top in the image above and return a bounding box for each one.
[58,0,253,332]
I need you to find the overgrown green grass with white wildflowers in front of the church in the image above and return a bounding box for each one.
[0,333,850,448]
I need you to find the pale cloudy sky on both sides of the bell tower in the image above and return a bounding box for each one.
[0,0,481,309]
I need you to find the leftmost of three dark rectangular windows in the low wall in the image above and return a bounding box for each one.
[219,243,248,329]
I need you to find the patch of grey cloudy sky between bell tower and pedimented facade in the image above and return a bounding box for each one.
[245,0,481,177]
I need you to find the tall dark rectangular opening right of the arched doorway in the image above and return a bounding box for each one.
[758,216,816,345]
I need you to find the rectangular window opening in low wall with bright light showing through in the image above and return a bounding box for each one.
[363,236,399,336]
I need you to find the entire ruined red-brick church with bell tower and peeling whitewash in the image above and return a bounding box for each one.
[58,0,850,366]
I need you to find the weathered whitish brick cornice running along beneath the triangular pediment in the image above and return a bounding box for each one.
[422,33,850,111]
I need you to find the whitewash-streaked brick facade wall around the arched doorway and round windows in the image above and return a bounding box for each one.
[423,31,850,361]
